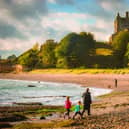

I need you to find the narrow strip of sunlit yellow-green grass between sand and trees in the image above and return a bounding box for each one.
[29,68,129,74]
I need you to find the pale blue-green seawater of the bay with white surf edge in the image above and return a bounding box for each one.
[0,79,112,106]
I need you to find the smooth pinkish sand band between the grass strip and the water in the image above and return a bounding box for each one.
[0,73,129,91]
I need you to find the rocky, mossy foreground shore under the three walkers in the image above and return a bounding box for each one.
[0,91,129,129]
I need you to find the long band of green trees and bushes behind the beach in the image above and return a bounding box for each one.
[6,31,129,69]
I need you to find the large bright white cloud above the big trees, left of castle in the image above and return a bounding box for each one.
[41,13,113,41]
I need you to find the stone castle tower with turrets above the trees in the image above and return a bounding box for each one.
[109,12,129,42]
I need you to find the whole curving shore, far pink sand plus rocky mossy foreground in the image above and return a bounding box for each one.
[0,73,129,129]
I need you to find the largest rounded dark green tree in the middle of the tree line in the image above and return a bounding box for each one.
[55,32,95,68]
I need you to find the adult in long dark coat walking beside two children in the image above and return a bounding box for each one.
[82,88,92,117]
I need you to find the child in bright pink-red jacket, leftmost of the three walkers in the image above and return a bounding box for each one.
[64,96,72,119]
